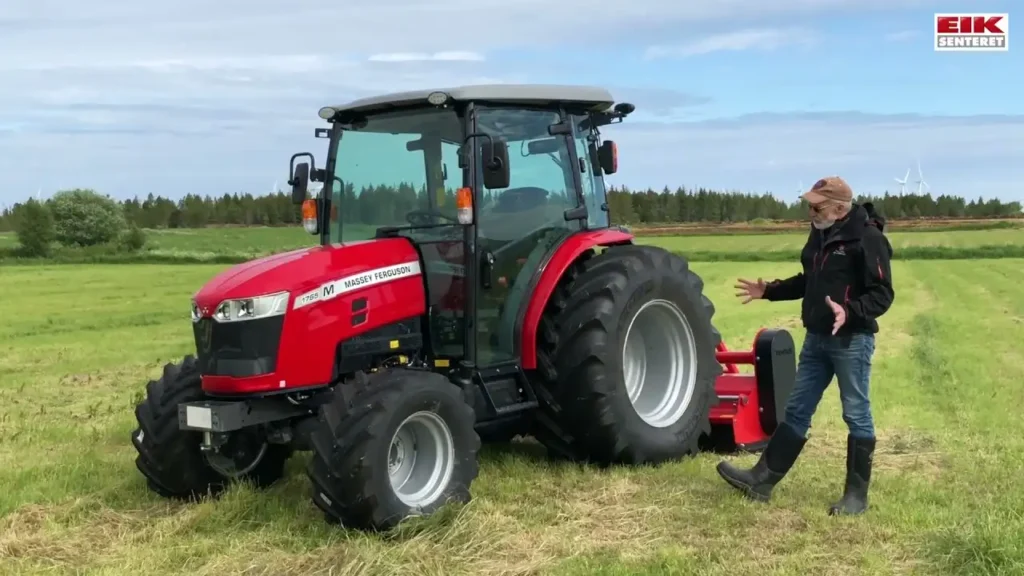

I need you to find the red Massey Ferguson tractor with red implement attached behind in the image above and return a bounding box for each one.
[132,85,796,530]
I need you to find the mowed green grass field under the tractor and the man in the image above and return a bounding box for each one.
[0,259,1024,576]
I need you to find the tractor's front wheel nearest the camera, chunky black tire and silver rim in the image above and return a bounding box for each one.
[307,369,480,531]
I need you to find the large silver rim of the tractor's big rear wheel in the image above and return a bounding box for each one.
[623,299,697,428]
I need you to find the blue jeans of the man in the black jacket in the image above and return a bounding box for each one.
[785,333,874,439]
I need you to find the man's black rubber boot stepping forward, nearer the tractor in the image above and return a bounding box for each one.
[718,423,807,502]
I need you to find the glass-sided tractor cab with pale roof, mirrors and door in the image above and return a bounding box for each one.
[291,86,633,375]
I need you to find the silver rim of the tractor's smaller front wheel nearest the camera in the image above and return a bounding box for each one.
[388,412,455,508]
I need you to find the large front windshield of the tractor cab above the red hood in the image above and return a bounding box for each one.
[330,109,463,244]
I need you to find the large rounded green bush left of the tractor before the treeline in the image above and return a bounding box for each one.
[50,189,128,246]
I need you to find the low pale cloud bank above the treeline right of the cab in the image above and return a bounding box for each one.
[605,113,1024,200]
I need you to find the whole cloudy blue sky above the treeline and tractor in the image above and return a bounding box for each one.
[0,0,1024,206]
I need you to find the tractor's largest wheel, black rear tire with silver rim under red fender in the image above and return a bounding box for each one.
[535,245,722,464]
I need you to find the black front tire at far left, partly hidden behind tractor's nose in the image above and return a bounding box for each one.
[131,356,292,500]
